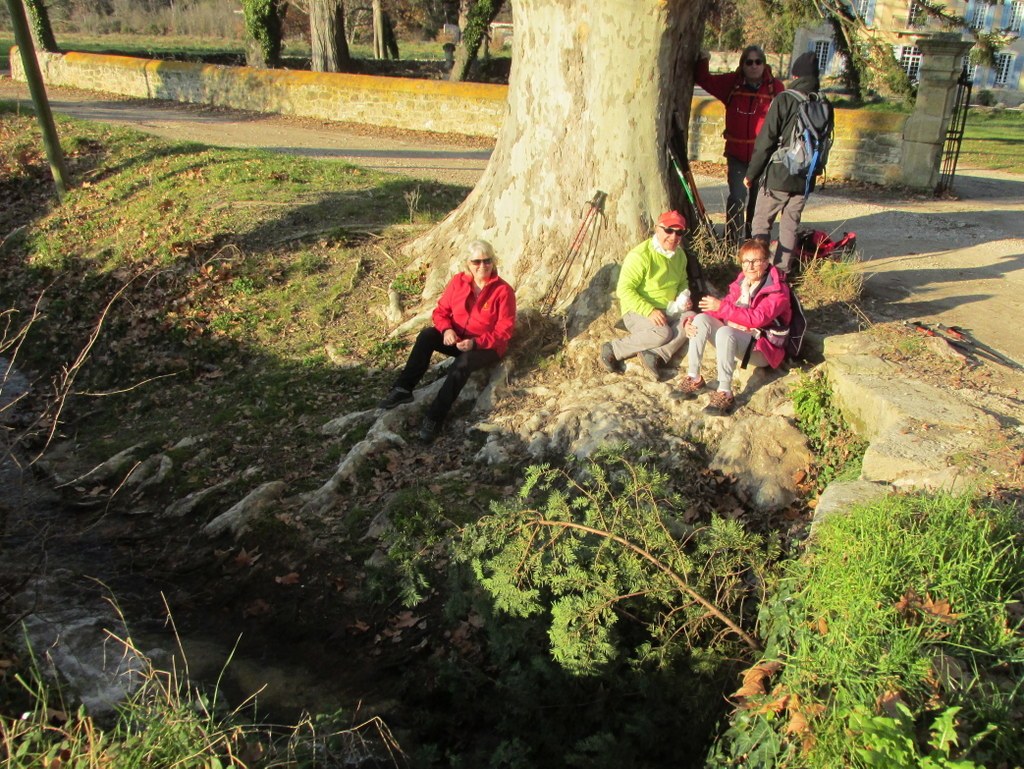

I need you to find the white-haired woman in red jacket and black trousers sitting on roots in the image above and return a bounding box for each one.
[379,241,515,443]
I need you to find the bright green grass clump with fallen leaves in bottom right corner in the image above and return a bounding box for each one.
[715,495,1024,769]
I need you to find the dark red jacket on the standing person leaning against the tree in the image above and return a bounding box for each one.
[695,58,785,163]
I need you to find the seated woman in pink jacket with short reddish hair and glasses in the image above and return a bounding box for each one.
[679,240,793,415]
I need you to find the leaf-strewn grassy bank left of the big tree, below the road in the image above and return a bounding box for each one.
[0,113,468,495]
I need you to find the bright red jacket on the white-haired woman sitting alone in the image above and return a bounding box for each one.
[434,272,515,355]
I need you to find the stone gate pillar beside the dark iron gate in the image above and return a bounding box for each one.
[900,33,972,190]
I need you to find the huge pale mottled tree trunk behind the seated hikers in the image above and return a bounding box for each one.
[408,0,711,315]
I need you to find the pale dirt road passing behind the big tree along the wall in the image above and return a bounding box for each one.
[6,75,1024,364]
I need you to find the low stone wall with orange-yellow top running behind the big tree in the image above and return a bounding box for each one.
[10,49,907,183]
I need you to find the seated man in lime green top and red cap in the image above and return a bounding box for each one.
[599,211,693,382]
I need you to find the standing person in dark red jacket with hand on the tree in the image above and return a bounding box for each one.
[695,45,785,243]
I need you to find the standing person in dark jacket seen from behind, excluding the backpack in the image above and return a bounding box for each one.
[743,51,818,274]
